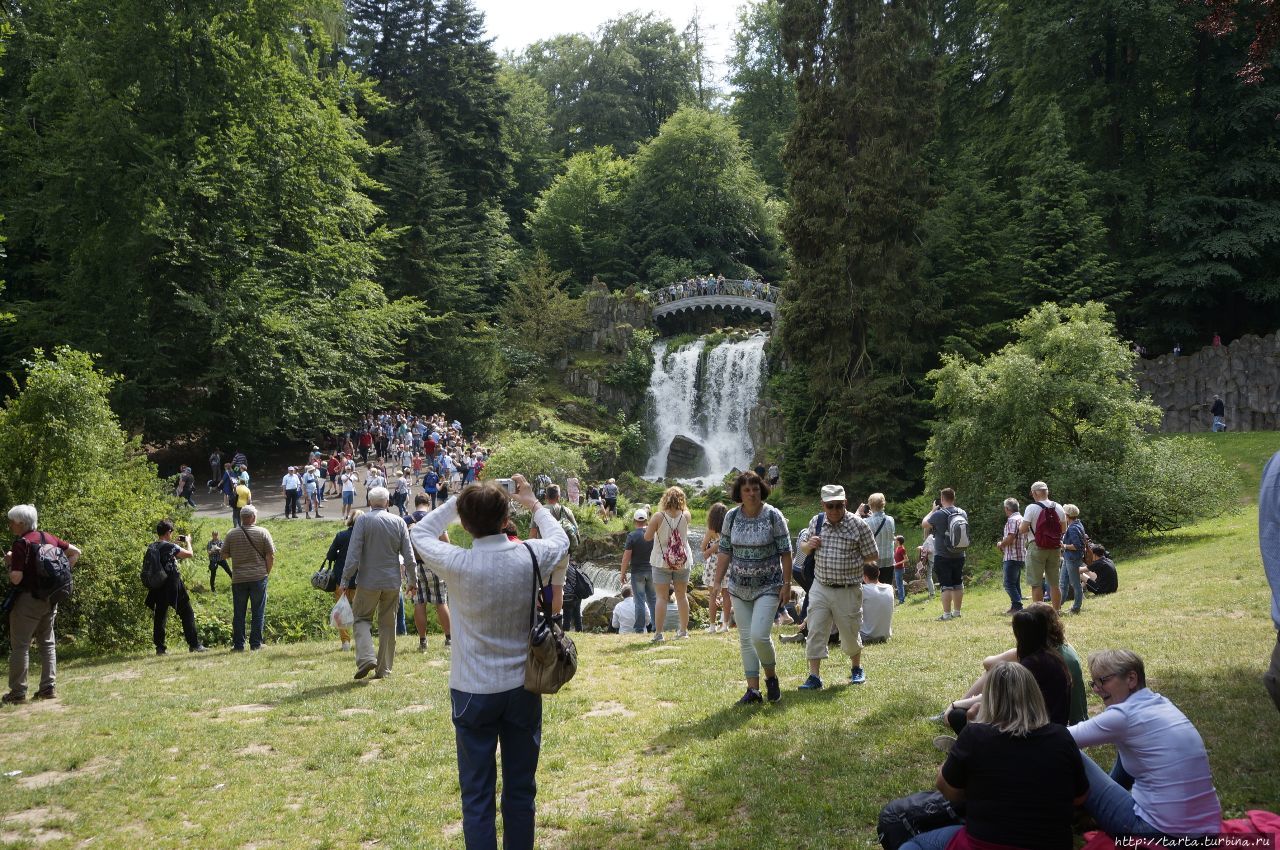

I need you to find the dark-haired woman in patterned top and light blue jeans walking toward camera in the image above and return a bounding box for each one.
[716,472,791,705]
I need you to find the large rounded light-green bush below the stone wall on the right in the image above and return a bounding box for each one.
[925,308,1234,543]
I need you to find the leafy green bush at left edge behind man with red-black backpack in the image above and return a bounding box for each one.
[0,348,183,652]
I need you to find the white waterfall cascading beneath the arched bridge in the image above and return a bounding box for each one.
[645,334,768,484]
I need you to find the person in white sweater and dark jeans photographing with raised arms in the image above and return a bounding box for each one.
[410,475,568,850]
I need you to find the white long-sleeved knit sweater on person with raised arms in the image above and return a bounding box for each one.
[410,497,568,694]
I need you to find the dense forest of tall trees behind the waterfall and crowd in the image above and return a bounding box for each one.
[0,0,1280,490]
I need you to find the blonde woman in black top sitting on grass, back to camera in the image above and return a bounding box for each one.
[902,662,1089,850]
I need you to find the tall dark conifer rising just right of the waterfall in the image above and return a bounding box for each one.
[778,0,942,492]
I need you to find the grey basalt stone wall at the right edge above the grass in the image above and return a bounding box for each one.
[1134,334,1280,433]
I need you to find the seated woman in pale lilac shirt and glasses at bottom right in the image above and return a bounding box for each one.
[1069,649,1222,836]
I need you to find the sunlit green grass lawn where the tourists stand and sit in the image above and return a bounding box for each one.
[0,435,1280,850]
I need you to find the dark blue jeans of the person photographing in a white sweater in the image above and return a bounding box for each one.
[449,687,543,850]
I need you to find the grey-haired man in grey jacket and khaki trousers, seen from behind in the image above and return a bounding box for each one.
[338,486,413,678]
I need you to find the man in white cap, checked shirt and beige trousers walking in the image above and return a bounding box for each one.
[796,484,879,690]
